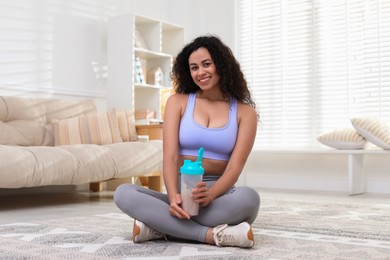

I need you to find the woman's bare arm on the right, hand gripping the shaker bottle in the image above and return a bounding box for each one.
[194,103,257,207]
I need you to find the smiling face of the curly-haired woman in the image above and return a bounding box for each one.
[188,48,219,90]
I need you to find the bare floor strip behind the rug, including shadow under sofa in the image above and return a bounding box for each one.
[0,187,390,224]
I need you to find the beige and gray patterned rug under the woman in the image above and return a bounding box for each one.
[0,196,390,260]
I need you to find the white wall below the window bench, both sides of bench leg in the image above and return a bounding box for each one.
[240,151,390,194]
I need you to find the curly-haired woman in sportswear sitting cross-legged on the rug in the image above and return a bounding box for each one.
[114,36,260,247]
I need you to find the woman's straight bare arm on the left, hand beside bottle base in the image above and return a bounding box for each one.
[163,94,190,219]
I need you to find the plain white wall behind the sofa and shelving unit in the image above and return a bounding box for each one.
[0,0,234,109]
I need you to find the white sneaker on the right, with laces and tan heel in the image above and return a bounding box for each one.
[213,222,255,247]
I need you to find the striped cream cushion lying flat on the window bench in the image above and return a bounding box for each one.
[317,129,367,149]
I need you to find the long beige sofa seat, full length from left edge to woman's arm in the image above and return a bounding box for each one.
[0,140,162,188]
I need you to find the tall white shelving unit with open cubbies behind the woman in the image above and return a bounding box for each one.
[107,14,184,124]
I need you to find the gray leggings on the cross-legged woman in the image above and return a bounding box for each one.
[114,175,260,242]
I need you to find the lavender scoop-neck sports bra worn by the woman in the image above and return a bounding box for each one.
[179,93,238,161]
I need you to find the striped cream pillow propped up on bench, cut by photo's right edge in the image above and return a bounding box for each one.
[351,117,390,149]
